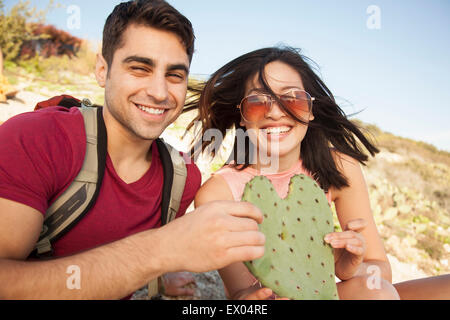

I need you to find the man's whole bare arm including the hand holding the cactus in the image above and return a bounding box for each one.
[0,198,264,299]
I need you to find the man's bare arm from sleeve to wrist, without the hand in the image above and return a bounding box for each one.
[0,198,167,299]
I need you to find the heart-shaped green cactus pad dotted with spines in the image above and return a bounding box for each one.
[242,174,338,300]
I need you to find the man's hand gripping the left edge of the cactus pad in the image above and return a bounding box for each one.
[157,201,265,272]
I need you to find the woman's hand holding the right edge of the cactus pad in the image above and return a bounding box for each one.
[324,219,367,280]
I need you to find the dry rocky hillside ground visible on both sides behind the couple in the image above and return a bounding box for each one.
[0,68,450,299]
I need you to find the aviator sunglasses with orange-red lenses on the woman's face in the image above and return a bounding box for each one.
[237,89,315,122]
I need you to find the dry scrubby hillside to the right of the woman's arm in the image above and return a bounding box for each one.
[364,125,450,275]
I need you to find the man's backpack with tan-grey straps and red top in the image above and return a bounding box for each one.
[33,95,187,296]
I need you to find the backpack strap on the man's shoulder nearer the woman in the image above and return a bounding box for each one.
[147,138,187,297]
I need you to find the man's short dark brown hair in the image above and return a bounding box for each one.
[102,0,195,66]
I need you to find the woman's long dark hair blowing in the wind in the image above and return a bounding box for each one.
[188,47,379,190]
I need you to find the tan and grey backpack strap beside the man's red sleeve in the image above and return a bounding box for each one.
[35,106,107,257]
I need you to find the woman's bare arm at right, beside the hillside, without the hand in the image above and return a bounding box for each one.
[331,153,392,282]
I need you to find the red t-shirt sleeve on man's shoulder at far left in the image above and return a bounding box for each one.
[0,107,86,214]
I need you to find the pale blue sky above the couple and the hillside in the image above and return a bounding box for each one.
[5,0,450,151]
